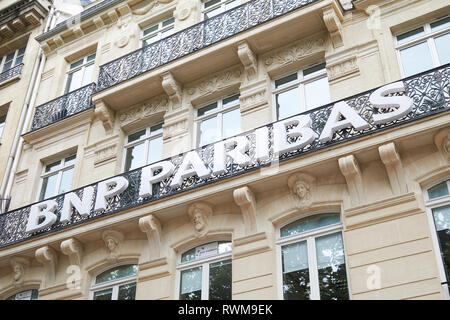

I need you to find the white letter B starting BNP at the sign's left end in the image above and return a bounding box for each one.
[25,200,58,232]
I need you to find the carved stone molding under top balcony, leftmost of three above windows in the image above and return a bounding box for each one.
[118,95,169,128]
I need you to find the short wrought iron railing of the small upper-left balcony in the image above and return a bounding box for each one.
[31,83,95,131]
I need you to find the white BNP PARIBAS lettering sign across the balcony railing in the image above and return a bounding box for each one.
[21,82,428,235]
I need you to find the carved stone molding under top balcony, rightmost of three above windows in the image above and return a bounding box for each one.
[263,36,325,72]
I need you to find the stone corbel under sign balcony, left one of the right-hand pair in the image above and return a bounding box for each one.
[338,155,364,206]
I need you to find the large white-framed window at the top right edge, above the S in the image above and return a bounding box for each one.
[396,17,450,77]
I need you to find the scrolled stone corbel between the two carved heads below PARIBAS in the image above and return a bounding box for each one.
[233,186,256,235]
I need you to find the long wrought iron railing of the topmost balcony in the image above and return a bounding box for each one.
[97,0,318,91]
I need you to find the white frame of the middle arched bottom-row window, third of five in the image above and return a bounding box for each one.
[175,240,233,300]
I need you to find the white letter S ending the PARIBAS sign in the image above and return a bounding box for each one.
[369,81,413,124]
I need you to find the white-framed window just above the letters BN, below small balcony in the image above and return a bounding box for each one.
[39,154,76,201]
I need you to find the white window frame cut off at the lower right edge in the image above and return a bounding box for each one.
[422,177,450,300]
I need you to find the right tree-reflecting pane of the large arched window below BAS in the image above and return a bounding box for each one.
[316,233,348,300]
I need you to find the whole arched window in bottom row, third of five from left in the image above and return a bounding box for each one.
[178,241,231,300]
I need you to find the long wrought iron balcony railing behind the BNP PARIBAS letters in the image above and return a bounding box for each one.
[0,64,450,247]
